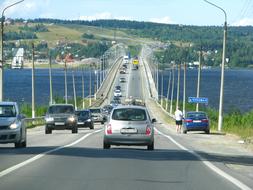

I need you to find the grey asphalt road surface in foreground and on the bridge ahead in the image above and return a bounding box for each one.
[0,58,250,190]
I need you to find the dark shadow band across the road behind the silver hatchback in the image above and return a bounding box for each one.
[0,146,253,166]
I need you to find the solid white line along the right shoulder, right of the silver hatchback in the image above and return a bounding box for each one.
[155,128,252,190]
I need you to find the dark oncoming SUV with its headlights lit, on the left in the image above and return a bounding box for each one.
[45,104,78,134]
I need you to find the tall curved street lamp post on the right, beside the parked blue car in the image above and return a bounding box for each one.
[204,0,227,131]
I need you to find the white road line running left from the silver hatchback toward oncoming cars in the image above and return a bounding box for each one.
[0,129,103,178]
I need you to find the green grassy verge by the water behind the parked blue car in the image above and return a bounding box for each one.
[159,99,253,140]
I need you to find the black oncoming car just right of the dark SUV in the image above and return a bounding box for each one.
[75,110,94,129]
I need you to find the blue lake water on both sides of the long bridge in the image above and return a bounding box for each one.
[4,69,253,112]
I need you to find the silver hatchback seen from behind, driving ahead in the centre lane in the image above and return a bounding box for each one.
[103,105,156,150]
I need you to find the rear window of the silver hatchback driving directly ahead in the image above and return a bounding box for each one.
[112,108,147,121]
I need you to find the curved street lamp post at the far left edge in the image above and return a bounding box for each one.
[0,0,24,101]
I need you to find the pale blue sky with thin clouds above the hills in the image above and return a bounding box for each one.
[0,0,253,26]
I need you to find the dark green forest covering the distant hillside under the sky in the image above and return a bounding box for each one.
[9,19,253,67]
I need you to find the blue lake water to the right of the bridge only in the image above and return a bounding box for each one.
[159,69,253,112]
